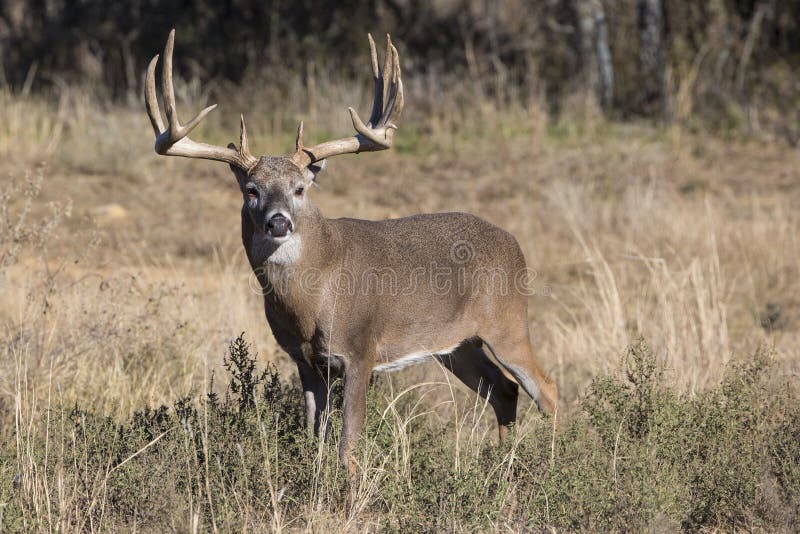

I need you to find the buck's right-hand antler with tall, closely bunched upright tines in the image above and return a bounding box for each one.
[292,34,403,168]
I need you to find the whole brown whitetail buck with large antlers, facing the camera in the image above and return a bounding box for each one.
[145,30,557,472]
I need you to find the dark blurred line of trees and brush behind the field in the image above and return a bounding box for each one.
[0,0,800,138]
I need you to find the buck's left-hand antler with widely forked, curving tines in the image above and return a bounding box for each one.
[144,29,258,172]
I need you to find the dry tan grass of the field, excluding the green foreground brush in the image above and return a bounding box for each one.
[0,87,800,530]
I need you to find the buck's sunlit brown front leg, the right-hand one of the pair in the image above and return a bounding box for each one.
[339,356,372,476]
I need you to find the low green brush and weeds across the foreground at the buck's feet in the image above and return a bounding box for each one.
[0,336,800,532]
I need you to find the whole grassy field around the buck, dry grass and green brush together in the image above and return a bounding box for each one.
[0,83,800,532]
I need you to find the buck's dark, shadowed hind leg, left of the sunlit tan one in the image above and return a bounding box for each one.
[436,341,519,441]
